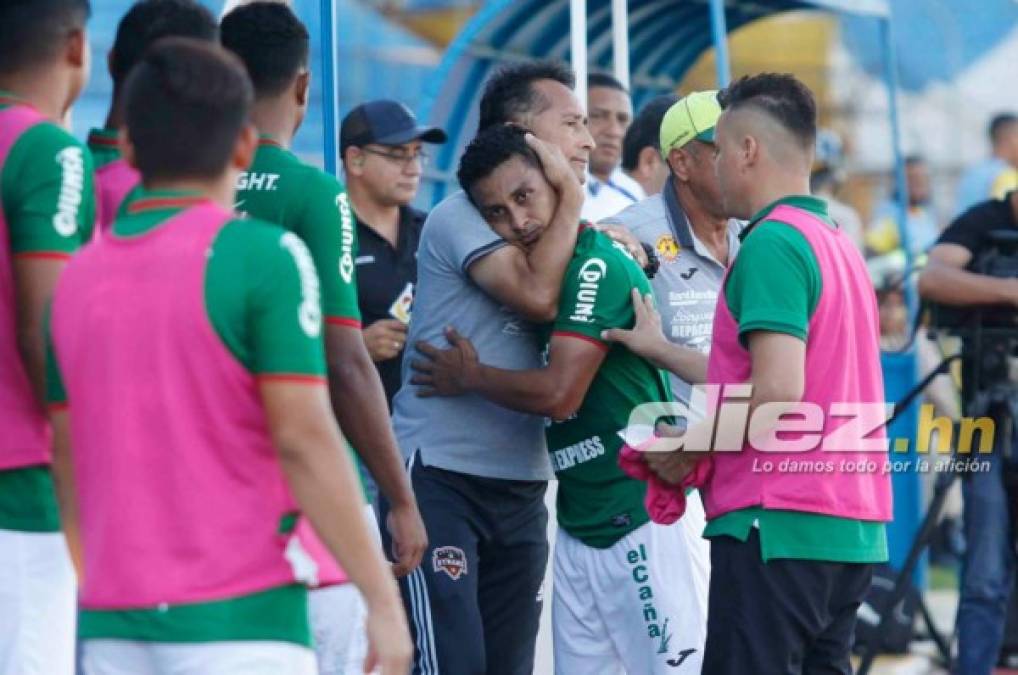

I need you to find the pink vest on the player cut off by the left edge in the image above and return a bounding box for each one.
[0,105,50,470]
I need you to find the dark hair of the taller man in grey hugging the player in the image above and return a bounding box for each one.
[477,61,576,132]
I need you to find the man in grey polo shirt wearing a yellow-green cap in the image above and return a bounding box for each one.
[606,92,742,411]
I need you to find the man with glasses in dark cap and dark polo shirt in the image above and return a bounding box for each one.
[340,100,446,409]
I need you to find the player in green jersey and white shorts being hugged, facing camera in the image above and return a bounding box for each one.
[412,126,708,674]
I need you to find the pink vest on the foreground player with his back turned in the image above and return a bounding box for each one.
[52,203,297,609]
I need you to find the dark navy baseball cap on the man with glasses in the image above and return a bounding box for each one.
[339,99,447,155]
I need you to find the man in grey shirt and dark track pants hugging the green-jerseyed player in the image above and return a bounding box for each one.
[381,62,593,675]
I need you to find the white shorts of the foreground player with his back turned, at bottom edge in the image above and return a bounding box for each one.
[82,639,318,675]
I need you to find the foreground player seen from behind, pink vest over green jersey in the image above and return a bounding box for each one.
[47,38,412,675]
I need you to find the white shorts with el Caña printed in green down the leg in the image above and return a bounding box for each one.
[552,493,711,675]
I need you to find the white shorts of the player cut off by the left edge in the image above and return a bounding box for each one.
[0,529,77,675]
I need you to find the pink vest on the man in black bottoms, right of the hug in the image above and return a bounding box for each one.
[704,206,892,521]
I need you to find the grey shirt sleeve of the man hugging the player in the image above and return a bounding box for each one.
[428,192,506,274]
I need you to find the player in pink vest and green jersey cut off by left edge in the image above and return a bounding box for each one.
[0,0,95,675]
